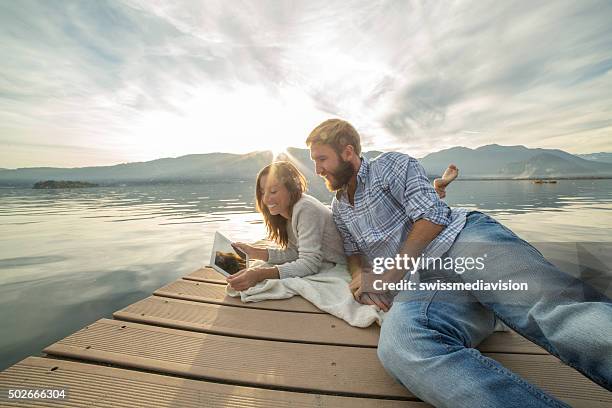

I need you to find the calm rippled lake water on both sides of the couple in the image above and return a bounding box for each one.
[0,180,612,369]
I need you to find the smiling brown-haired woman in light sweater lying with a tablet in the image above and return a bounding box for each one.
[227,161,458,291]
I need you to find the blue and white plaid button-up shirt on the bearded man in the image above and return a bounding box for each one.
[331,153,468,262]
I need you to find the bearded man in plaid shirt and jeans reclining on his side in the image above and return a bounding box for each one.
[306,119,612,408]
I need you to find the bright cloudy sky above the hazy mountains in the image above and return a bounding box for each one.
[0,0,612,168]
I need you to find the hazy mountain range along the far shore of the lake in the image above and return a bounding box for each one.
[0,144,612,187]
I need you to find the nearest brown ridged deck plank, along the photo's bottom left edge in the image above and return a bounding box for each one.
[0,357,431,408]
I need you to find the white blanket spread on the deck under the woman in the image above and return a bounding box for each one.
[226,265,385,327]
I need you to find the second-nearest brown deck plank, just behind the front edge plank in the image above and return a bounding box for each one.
[44,319,415,399]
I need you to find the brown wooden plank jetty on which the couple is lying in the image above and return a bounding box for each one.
[0,268,612,408]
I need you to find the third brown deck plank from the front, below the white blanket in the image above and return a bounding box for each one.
[113,296,380,347]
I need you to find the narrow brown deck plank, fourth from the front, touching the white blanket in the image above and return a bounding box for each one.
[153,279,325,313]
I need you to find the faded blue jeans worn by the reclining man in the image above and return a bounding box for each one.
[378,212,612,408]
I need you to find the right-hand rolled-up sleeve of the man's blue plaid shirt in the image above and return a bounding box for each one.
[388,155,451,226]
